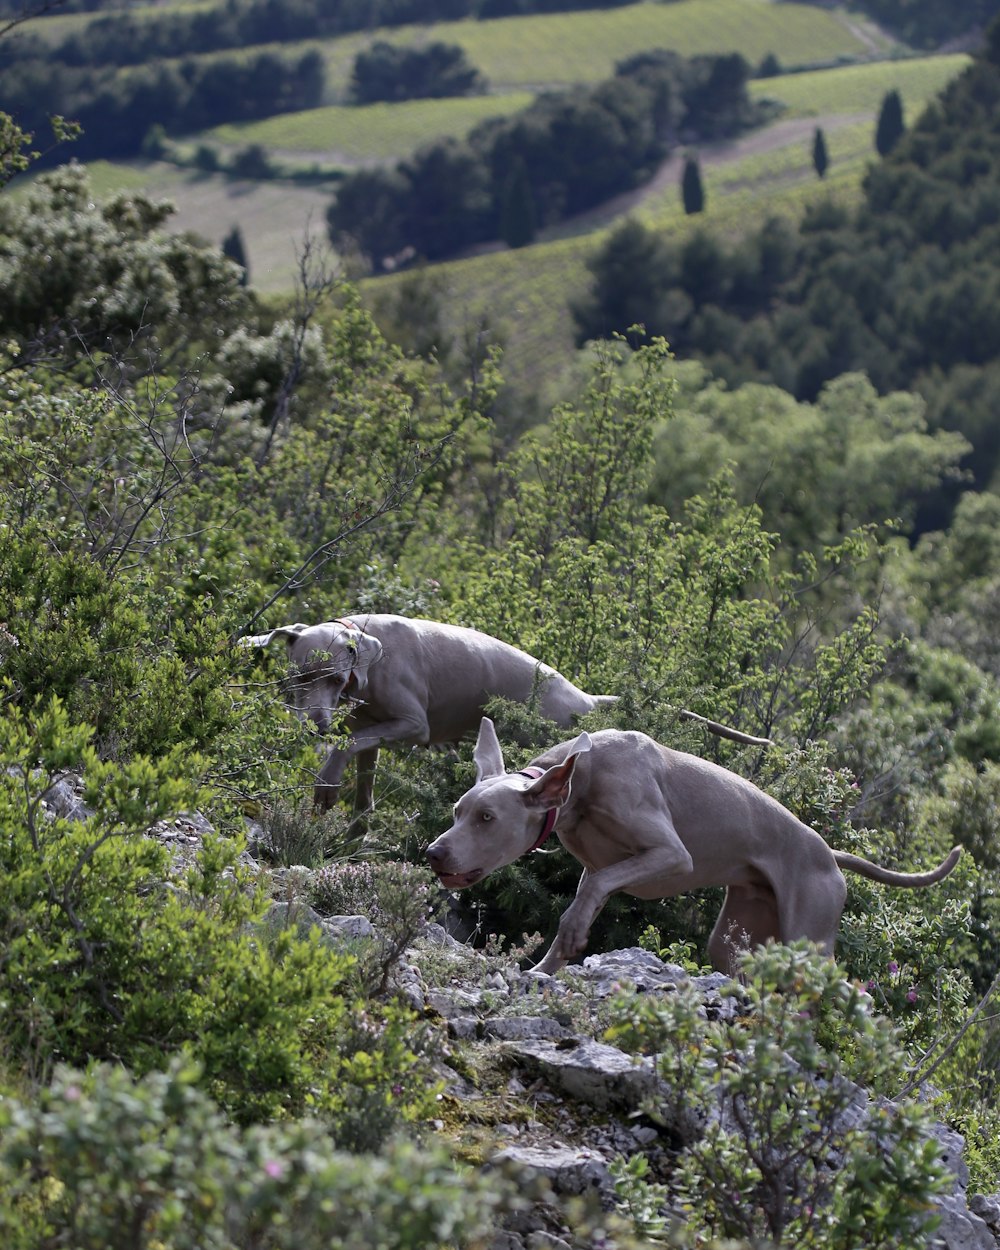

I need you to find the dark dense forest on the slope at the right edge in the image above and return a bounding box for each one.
[575,23,1000,527]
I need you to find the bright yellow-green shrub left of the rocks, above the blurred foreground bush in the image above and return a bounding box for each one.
[0,701,436,1145]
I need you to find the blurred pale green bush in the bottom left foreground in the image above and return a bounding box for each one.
[0,1063,518,1250]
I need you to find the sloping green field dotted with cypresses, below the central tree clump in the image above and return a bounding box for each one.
[363,56,968,399]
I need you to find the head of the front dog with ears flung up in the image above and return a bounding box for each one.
[428,716,590,890]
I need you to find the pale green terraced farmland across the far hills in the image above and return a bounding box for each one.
[23,0,966,385]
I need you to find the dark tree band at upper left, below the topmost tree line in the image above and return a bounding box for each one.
[4,51,325,160]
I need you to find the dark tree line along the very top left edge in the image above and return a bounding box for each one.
[0,0,634,69]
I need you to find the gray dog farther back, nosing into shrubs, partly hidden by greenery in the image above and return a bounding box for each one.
[240,613,615,816]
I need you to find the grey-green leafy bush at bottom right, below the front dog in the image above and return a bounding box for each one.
[611,944,948,1250]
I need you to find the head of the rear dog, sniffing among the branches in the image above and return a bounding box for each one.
[240,621,383,734]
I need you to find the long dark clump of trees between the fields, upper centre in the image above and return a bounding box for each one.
[328,51,760,270]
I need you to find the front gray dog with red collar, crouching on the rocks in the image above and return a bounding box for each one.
[428,718,961,973]
